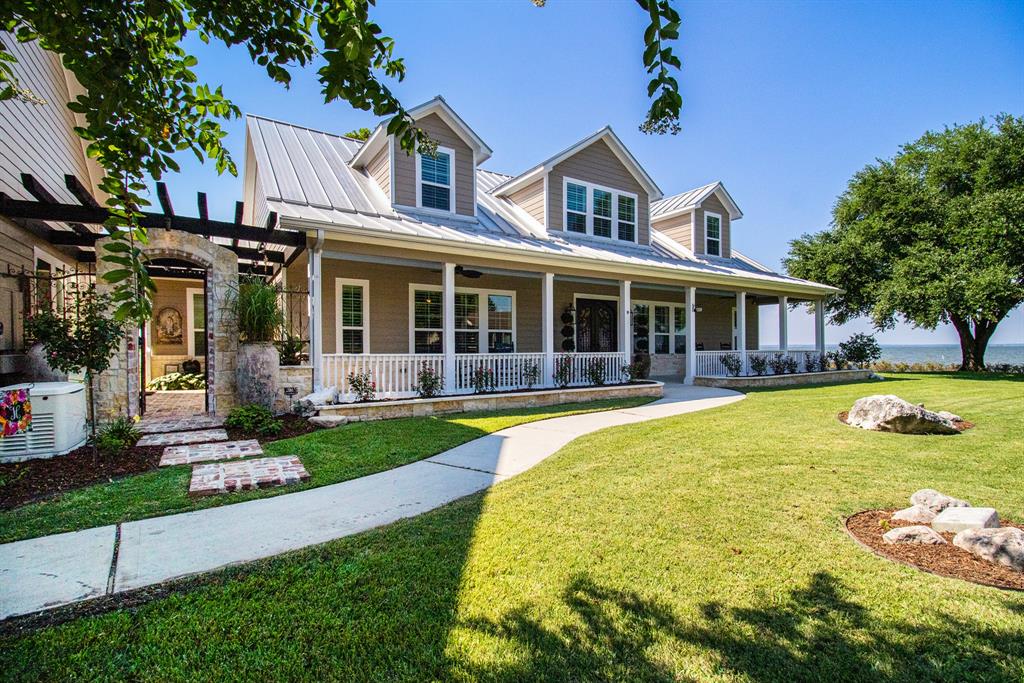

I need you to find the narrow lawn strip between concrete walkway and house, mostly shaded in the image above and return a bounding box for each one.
[0,398,651,543]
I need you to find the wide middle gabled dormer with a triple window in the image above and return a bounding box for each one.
[493,126,662,245]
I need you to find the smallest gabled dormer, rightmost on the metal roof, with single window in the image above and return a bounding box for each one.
[650,181,743,258]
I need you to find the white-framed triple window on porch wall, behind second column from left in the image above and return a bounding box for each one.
[410,285,515,353]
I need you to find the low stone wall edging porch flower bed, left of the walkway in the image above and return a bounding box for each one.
[319,382,665,420]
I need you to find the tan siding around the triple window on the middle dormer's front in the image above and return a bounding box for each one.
[548,140,650,245]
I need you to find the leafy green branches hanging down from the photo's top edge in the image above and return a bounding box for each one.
[0,0,682,325]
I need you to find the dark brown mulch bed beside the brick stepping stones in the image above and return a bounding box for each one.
[0,415,316,510]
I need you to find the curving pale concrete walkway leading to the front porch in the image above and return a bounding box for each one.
[0,384,743,620]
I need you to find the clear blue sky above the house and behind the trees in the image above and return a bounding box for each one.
[159,0,1024,343]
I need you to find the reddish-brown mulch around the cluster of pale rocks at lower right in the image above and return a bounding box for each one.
[846,509,1024,591]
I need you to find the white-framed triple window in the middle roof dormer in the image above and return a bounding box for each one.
[564,178,637,242]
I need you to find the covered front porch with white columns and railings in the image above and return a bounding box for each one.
[285,241,831,400]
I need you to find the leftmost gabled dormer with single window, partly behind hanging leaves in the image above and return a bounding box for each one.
[351,95,492,217]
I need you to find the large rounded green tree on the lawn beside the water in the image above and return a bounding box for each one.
[784,114,1024,371]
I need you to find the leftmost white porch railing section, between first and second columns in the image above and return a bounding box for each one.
[323,353,444,400]
